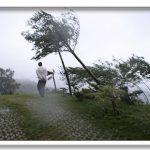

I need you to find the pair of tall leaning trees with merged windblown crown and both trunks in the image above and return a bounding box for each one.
[22,10,99,94]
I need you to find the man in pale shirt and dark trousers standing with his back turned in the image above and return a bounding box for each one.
[36,62,47,97]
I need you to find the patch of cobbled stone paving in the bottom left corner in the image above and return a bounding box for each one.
[0,107,25,141]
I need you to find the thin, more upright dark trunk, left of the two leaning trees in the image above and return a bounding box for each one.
[58,49,72,95]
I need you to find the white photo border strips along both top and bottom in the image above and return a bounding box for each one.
[0,0,150,146]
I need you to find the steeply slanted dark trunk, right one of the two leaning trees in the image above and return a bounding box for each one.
[65,43,100,85]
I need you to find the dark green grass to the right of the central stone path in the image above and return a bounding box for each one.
[64,96,150,140]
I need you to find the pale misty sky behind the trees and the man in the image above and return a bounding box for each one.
[0,8,150,88]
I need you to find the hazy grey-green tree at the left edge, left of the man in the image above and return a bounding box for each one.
[0,68,19,94]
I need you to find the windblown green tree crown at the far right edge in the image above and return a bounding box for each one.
[114,55,150,84]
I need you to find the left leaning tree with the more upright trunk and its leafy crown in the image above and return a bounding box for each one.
[22,11,79,95]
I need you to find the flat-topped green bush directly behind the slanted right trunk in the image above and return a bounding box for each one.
[60,61,118,92]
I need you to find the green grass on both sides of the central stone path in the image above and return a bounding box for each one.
[0,95,150,140]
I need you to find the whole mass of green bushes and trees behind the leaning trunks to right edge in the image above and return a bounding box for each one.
[60,55,150,104]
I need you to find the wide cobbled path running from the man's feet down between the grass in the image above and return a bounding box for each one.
[28,96,111,140]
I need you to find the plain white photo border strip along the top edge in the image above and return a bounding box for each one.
[0,0,150,7]
